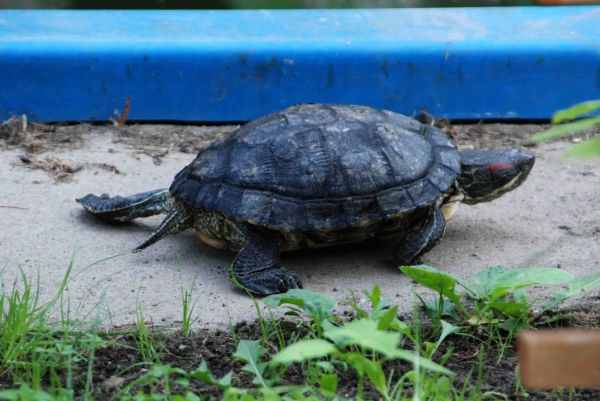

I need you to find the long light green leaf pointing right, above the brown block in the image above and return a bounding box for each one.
[490,268,573,301]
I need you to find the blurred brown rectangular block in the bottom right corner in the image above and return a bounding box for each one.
[517,329,600,389]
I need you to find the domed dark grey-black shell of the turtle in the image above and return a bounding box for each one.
[170,104,460,231]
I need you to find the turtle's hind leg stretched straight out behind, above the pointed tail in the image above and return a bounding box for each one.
[76,188,173,223]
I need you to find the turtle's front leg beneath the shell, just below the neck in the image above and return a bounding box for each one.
[392,205,446,266]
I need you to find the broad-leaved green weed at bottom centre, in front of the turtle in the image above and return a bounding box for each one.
[265,286,453,400]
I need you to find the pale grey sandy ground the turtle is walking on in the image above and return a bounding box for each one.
[0,122,600,328]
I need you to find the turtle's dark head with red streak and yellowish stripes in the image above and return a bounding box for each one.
[456,149,535,205]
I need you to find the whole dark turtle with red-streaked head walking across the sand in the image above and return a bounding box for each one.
[76,103,535,295]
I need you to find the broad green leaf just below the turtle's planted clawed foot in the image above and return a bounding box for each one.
[263,288,336,322]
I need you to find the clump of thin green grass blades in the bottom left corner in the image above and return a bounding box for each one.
[0,251,110,392]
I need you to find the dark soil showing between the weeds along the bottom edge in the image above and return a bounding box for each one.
[0,307,600,401]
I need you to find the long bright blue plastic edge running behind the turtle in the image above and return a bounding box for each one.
[0,6,600,122]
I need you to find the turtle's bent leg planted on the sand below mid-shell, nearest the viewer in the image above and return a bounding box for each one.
[231,230,302,295]
